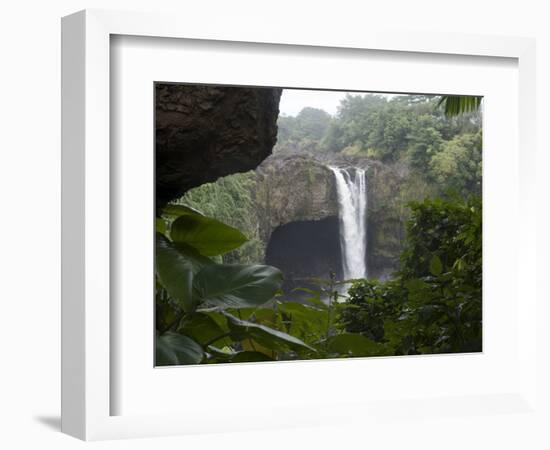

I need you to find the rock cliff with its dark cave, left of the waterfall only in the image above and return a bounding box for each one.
[255,156,342,299]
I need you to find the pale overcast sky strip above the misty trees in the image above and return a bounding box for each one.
[279,89,404,116]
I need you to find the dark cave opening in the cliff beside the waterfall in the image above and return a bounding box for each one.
[266,216,342,299]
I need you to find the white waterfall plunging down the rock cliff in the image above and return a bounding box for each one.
[330,167,367,280]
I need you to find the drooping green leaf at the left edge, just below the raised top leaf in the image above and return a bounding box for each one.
[155,233,195,312]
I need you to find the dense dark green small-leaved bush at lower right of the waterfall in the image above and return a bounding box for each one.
[339,197,482,354]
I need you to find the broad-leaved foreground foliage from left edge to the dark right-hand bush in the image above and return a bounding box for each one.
[156,211,396,365]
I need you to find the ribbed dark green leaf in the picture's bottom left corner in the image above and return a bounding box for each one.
[155,332,204,366]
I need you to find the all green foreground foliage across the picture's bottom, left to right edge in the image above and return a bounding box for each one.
[156,197,482,365]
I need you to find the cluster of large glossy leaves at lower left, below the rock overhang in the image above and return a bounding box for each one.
[156,206,322,365]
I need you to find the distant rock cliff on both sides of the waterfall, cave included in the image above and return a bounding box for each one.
[255,155,411,282]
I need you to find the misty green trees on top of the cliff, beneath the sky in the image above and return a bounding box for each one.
[274,94,481,195]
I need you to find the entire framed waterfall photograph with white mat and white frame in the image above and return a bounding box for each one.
[62,11,537,440]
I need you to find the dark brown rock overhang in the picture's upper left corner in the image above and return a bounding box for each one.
[155,83,282,206]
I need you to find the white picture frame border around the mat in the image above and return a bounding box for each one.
[62,10,539,440]
